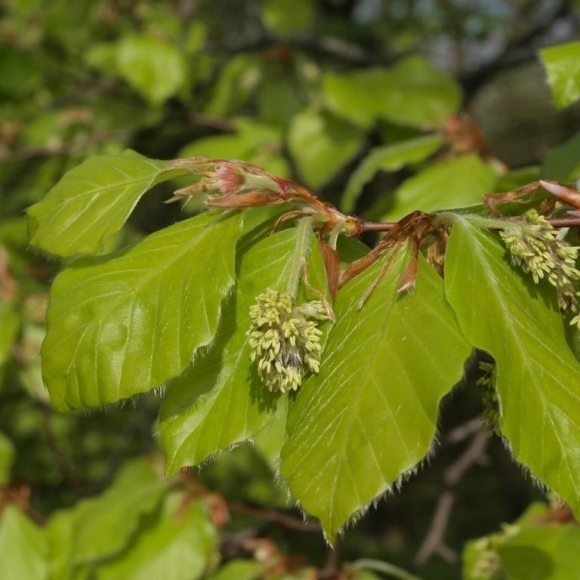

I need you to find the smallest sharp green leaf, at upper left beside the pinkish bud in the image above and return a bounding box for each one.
[28,151,187,256]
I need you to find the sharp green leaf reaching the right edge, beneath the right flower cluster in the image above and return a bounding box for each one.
[445,216,580,514]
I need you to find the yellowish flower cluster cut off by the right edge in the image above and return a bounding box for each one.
[500,209,580,326]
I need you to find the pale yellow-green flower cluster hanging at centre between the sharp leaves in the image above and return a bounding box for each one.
[247,288,328,393]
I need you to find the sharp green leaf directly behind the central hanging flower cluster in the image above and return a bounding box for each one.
[159,224,325,474]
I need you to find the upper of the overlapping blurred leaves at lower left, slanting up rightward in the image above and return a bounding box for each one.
[71,459,167,563]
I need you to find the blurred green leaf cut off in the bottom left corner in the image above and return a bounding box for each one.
[0,504,48,580]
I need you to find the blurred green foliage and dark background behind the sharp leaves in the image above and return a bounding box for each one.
[0,0,580,580]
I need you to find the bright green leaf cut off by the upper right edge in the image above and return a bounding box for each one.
[540,42,580,109]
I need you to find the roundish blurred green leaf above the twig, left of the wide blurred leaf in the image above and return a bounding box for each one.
[288,109,365,188]
